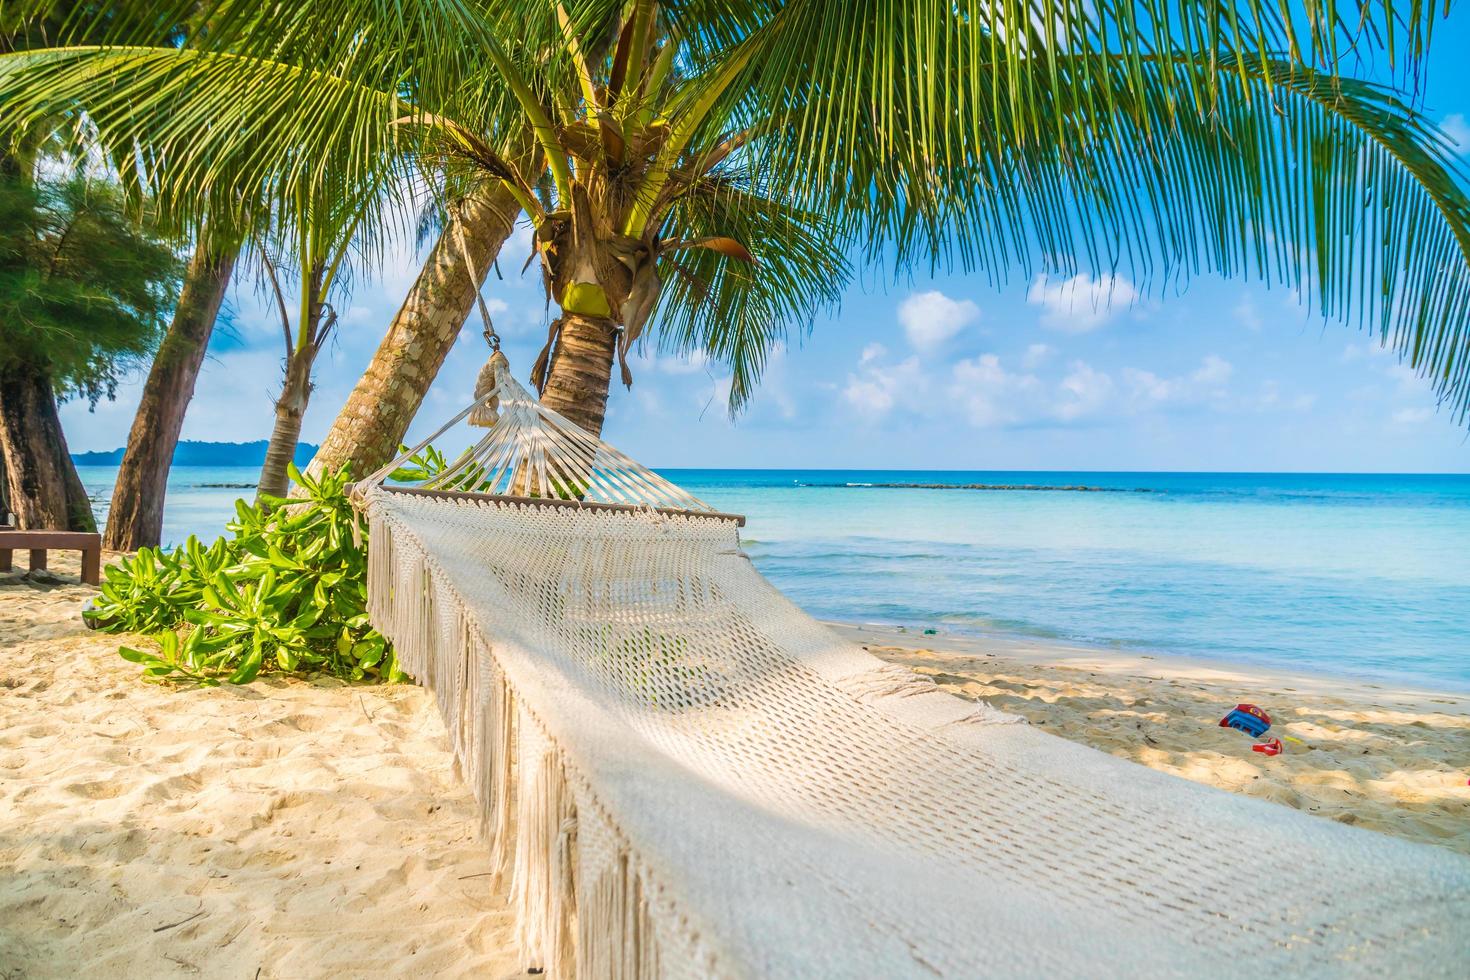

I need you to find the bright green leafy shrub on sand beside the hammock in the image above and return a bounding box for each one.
[87,466,406,685]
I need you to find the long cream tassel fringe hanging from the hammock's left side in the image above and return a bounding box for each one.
[368,514,663,980]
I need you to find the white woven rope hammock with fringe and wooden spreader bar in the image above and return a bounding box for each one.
[354,359,1470,979]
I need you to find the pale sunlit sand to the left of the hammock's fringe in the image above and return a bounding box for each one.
[0,555,520,980]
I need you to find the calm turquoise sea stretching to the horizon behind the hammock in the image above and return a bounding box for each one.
[79,466,1470,691]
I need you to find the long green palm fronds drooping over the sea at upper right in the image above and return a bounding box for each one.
[708,0,1470,416]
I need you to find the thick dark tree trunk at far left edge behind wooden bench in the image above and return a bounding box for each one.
[0,369,97,530]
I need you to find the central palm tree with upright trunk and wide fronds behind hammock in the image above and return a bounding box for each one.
[0,0,1470,461]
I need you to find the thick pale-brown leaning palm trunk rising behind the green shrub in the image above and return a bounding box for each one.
[309,182,520,476]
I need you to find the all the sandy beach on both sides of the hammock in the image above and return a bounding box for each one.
[0,558,1470,979]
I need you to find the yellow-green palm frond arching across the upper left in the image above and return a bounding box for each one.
[0,47,406,240]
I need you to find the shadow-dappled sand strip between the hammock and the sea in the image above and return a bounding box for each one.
[838,626,1470,854]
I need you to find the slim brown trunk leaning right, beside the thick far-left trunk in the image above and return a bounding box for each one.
[103,247,237,551]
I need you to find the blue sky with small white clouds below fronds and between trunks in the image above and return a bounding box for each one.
[62,10,1470,473]
